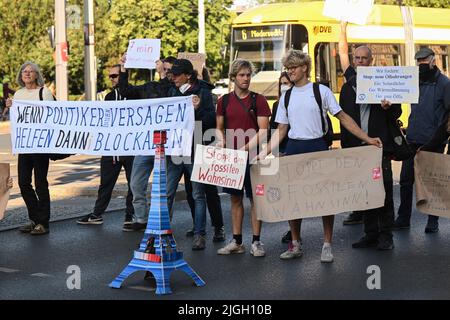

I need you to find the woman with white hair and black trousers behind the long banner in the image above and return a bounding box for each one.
[6,61,53,235]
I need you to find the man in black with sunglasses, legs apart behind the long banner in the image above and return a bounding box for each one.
[77,64,134,228]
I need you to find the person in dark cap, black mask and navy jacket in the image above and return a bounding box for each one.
[394,48,450,233]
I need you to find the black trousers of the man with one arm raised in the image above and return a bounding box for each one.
[358,156,394,239]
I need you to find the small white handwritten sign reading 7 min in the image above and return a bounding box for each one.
[125,39,161,69]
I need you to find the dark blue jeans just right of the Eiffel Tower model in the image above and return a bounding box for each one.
[167,157,206,235]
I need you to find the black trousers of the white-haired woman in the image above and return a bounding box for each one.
[17,154,50,228]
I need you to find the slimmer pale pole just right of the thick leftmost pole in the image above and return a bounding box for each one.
[84,0,97,100]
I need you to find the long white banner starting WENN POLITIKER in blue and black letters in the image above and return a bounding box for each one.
[10,96,195,156]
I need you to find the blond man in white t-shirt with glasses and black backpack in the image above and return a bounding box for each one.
[260,49,382,262]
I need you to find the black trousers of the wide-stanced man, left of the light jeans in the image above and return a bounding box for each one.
[93,156,134,217]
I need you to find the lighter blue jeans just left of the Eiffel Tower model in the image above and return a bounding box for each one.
[130,156,155,223]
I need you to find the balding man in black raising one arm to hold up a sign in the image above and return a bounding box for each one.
[339,22,402,250]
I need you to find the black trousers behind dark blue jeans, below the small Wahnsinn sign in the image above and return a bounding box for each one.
[184,174,223,228]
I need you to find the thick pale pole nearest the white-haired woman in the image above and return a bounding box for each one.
[55,0,68,101]
